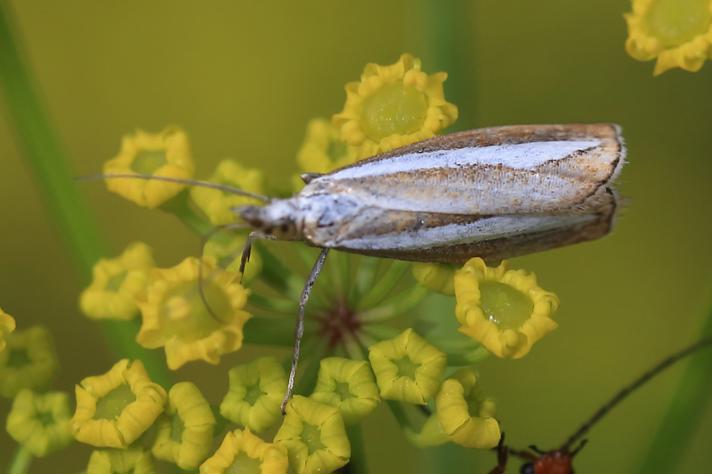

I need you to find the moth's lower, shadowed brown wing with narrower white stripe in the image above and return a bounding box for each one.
[308,189,617,264]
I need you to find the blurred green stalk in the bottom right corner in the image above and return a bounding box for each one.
[639,310,712,474]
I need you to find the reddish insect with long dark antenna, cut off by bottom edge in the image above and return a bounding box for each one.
[489,337,712,474]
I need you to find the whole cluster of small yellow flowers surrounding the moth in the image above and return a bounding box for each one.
[69,53,576,474]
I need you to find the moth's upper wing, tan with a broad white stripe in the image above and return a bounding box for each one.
[300,124,624,215]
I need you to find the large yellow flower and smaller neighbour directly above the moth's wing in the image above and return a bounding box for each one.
[297,54,457,178]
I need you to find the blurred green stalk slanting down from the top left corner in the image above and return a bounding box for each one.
[0,0,170,385]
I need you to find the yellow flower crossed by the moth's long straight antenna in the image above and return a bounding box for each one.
[104,127,193,208]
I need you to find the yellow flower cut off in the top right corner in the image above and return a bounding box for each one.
[625,0,712,75]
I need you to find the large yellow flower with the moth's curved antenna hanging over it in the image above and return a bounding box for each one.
[136,257,250,370]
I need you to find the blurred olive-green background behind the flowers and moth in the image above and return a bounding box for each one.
[0,0,712,473]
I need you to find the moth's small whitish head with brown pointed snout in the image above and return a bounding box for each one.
[236,199,301,240]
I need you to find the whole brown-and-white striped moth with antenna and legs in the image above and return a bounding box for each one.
[98,124,625,406]
